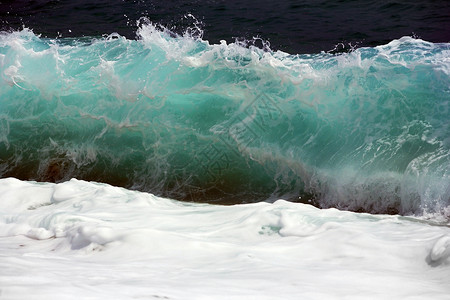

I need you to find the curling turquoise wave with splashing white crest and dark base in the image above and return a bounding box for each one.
[0,23,450,214]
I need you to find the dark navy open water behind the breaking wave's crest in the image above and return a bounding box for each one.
[0,0,450,53]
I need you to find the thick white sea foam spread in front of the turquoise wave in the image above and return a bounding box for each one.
[0,178,450,299]
